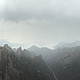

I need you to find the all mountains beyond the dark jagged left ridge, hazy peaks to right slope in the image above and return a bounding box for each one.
[28,41,80,80]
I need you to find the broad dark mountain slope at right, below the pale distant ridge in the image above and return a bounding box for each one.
[47,46,80,80]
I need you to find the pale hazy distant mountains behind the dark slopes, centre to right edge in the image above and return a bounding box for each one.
[27,41,80,60]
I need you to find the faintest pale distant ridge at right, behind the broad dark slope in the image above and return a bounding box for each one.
[55,41,80,48]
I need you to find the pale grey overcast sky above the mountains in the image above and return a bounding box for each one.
[0,0,80,47]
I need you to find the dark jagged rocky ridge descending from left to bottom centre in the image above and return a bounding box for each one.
[0,45,55,80]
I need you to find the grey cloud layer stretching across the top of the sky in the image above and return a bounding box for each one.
[0,0,80,21]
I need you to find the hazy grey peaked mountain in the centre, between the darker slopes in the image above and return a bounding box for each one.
[28,46,53,60]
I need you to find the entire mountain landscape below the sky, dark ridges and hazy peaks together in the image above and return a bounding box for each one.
[0,41,80,80]
